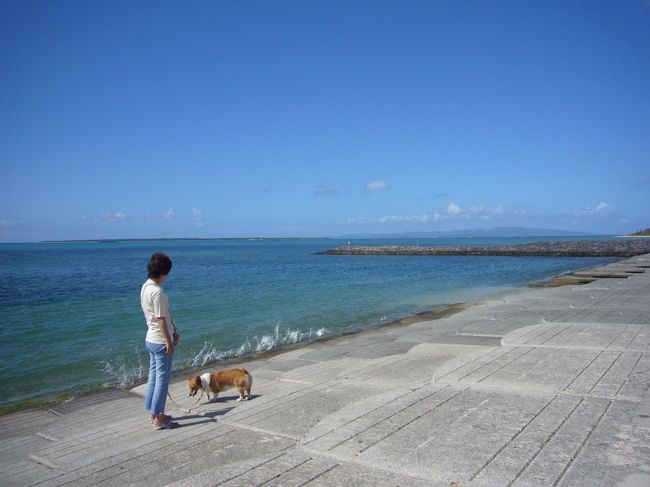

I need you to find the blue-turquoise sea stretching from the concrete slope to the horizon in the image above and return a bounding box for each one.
[0,238,611,406]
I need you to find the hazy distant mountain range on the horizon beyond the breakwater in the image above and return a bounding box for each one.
[335,227,594,239]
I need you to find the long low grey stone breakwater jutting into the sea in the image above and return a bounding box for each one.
[318,240,650,257]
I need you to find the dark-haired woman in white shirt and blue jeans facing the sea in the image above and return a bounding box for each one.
[140,254,180,430]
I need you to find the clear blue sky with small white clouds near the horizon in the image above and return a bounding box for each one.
[0,0,650,241]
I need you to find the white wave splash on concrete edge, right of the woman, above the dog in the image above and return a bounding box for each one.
[187,324,328,368]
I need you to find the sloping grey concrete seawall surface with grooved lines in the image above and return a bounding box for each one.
[0,254,650,487]
